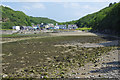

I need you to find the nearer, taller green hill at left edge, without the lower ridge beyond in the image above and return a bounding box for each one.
[2,6,31,29]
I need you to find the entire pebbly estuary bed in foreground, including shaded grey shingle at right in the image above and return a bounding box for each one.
[1,33,119,78]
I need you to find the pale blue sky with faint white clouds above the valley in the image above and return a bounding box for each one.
[2,0,118,22]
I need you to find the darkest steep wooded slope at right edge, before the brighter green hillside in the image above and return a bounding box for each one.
[96,3,120,32]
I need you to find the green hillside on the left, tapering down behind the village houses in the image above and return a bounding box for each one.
[0,6,56,29]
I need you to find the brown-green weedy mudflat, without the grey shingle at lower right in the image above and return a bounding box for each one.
[2,36,118,78]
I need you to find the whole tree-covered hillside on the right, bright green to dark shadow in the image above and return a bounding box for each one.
[76,3,120,31]
